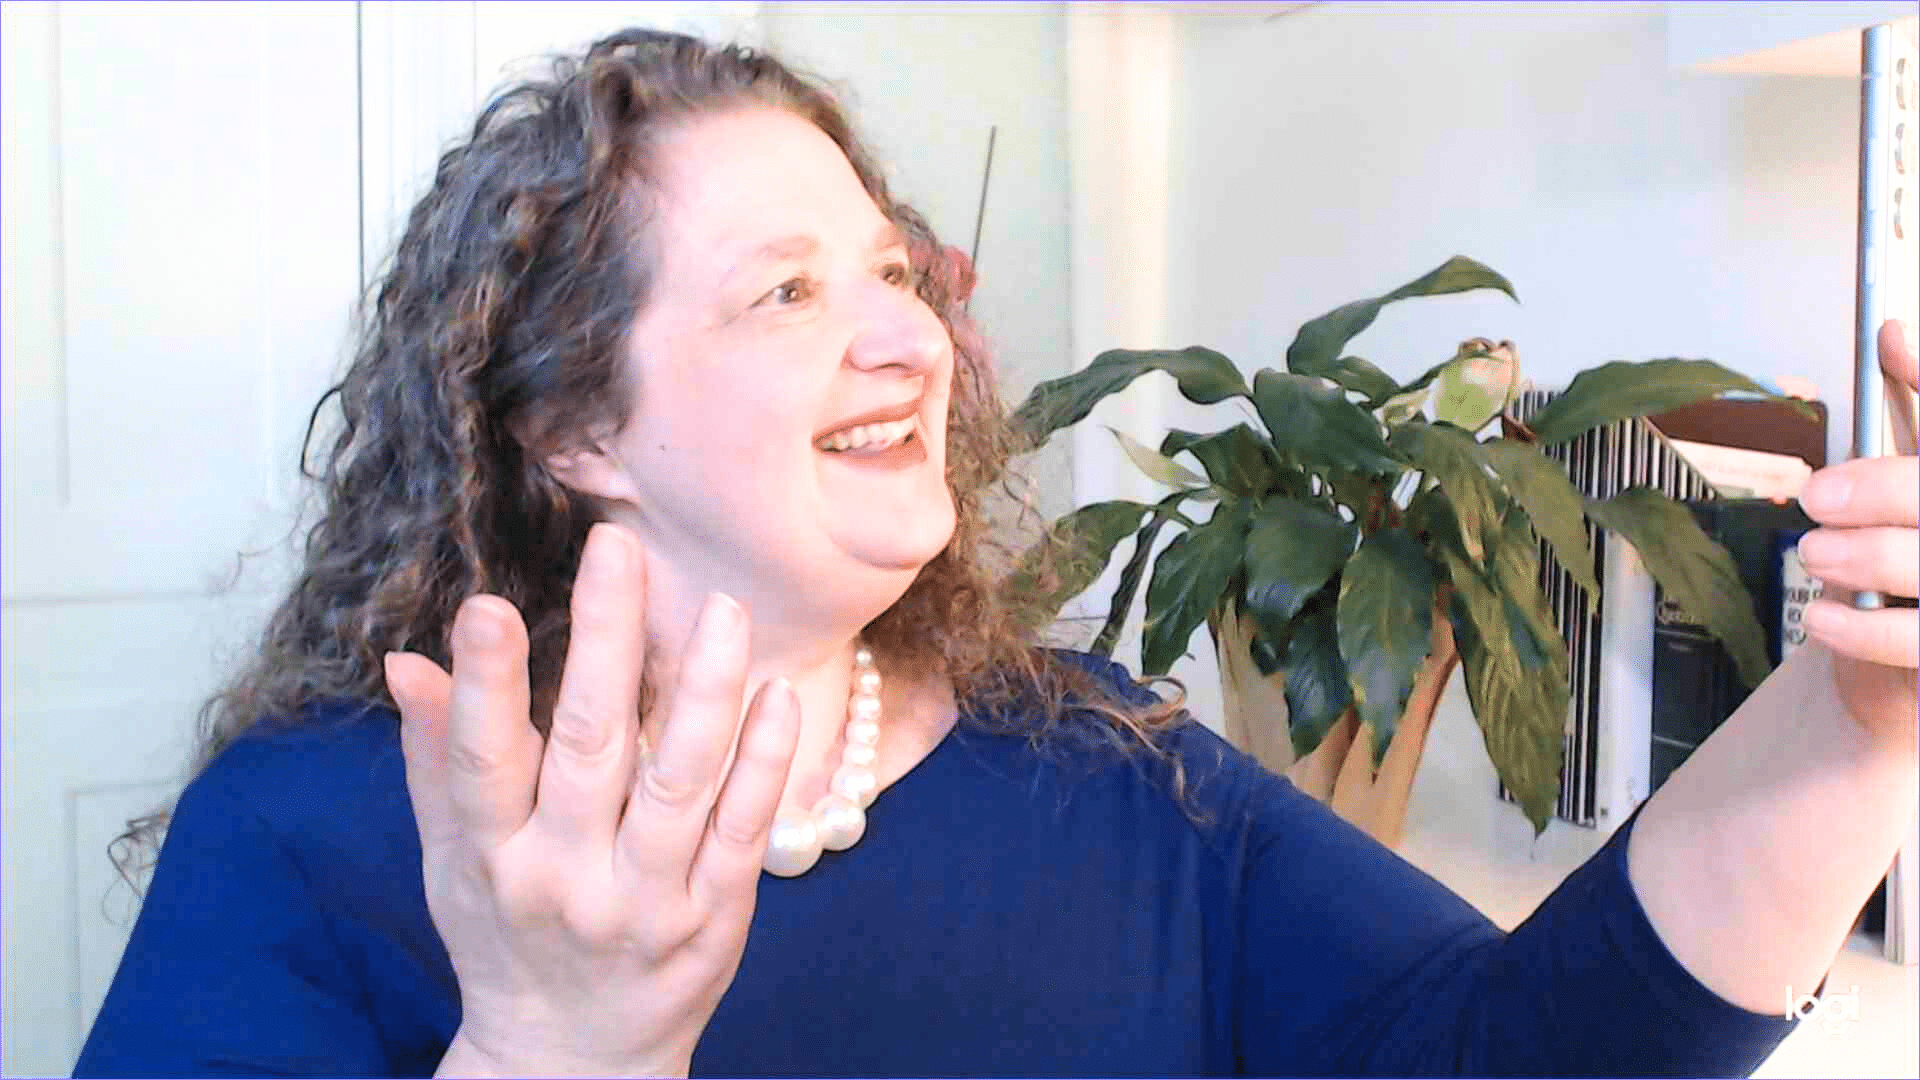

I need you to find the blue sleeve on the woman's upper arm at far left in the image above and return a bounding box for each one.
[73,748,390,1076]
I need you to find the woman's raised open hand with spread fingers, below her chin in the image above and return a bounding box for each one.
[386,525,799,1076]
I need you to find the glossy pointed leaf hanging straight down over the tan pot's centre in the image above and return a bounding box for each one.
[1338,528,1434,769]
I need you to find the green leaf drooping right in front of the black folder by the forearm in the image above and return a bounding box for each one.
[1586,486,1772,686]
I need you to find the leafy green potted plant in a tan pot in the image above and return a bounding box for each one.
[1010,258,1803,846]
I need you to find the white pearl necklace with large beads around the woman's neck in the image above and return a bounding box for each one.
[762,646,879,878]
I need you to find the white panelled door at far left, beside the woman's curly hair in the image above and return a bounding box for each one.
[0,2,359,1074]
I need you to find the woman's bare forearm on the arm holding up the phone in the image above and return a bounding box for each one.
[1626,644,1920,1013]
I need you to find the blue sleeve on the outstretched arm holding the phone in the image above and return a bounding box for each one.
[1235,776,1826,1076]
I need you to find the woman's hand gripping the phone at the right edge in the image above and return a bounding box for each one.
[1799,321,1920,753]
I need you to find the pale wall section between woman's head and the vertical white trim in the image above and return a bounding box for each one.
[760,4,1091,517]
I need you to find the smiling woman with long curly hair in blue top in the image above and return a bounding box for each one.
[77,31,1916,1076]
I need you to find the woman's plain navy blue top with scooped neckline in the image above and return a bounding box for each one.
[75,655,1824,1076]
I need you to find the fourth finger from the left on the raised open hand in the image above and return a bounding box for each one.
[618,592,747,892]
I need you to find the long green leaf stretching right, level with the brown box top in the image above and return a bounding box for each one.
[1526,359,1812,446]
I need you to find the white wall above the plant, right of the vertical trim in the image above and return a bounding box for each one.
[1169,4,1859,466]
